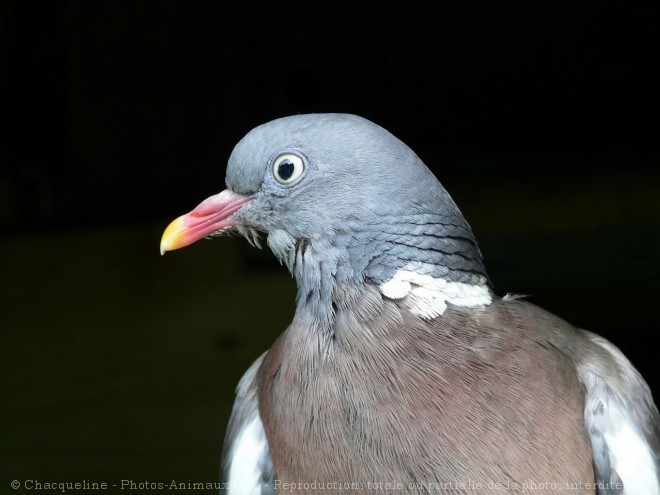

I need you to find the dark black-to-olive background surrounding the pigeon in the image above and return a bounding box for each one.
[0,0,660,489]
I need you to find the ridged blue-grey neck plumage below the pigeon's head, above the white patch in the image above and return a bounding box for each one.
[268,213,490,333]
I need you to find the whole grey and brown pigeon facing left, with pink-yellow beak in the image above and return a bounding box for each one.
[160,114,660,495]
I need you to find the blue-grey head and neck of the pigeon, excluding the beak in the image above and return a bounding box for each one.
[226,114,488,318]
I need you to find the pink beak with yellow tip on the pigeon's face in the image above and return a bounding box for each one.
[160,189,252,254]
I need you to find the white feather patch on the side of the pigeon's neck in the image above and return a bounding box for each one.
[379,266,493,318]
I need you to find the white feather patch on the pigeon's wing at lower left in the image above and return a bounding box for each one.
[227,413,270,495]
